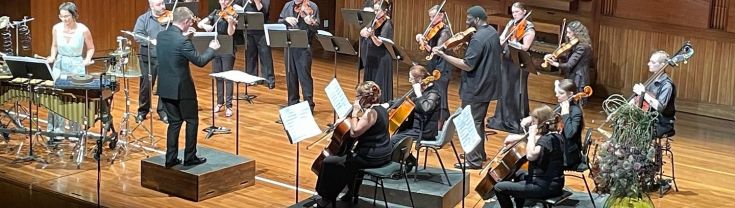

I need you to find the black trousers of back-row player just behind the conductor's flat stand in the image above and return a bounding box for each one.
[245,34,276,84]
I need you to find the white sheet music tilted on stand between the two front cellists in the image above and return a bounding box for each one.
[452,105,481,153]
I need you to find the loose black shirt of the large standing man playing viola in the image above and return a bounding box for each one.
[459,25,501,102]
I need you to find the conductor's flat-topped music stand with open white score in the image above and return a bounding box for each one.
[209,69,265,155]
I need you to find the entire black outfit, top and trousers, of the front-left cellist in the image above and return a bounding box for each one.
[316,106,393,201]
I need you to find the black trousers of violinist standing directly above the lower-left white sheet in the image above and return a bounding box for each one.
[286,48,314,110]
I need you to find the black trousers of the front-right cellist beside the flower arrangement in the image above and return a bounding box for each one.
[494,171,564,208]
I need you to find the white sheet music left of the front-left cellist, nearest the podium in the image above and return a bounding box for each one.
[278,101,322,144]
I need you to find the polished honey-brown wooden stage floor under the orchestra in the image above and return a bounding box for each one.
[0,46,735,207]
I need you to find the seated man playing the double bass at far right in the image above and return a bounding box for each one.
[632,51,676,138]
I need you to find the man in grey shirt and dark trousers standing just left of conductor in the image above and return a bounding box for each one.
[133,0,168,123]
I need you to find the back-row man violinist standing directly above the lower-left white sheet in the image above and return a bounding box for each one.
[278,0,319,111]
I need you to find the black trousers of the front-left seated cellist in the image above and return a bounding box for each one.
[316,156,390,201]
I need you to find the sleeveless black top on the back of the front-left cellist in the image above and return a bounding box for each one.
[355,106,393,161]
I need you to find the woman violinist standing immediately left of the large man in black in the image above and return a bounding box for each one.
[416,5,454,126]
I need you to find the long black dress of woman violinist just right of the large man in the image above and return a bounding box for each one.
[487,21,534,134]
